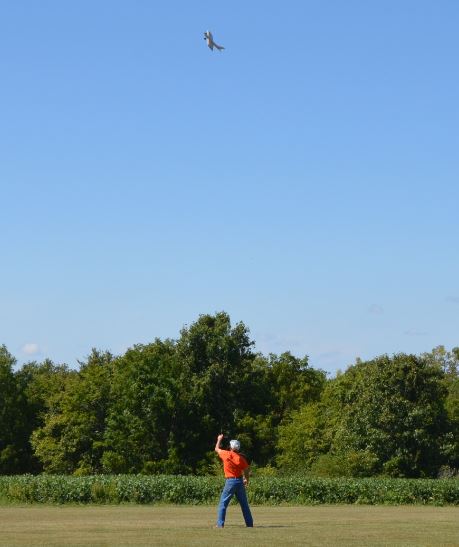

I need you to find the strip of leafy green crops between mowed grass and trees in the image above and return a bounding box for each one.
[0,475,459,506]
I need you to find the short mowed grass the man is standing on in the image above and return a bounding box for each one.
[0,505,459,547]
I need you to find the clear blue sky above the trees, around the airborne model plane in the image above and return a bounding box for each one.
[0,0,459,374]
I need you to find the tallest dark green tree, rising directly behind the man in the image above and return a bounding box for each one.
[173,312,255,472]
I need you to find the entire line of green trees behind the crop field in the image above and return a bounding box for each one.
[0,312,459,477]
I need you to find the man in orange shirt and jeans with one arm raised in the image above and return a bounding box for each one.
[215,434,253,528]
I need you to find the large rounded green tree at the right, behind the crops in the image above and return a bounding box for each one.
[332,354,447,477]
